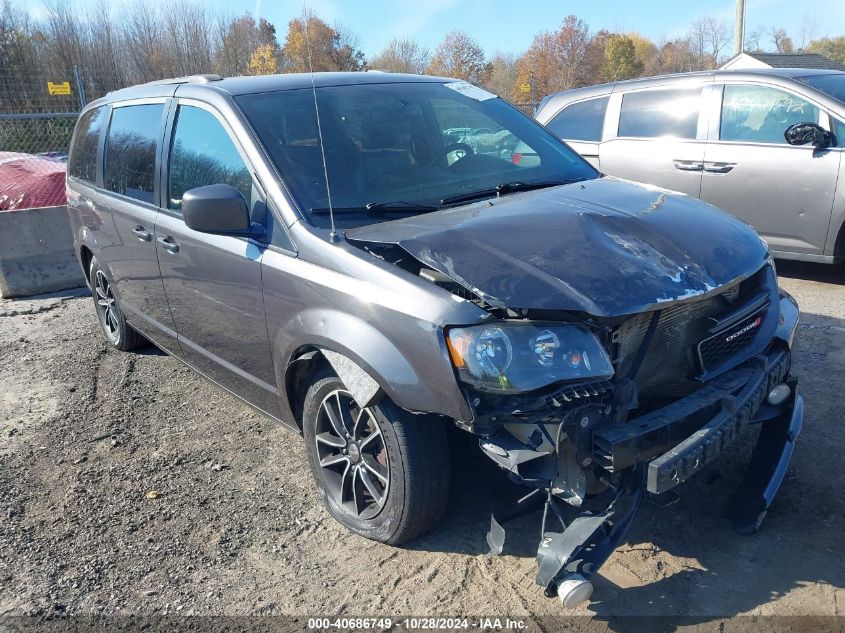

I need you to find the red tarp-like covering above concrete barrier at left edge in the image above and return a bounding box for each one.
[0,152,67,211]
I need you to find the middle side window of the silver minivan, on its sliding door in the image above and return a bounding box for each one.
[617,88,702,138]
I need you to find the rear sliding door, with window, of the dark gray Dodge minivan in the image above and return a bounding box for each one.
[99,99,178,351]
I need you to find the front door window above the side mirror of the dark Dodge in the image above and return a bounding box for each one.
[167,105,252,211]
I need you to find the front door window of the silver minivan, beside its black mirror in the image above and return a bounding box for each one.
[719,85,819,145]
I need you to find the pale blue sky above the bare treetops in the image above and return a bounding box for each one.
[29,0,845,56]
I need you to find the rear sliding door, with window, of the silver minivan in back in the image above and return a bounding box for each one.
[599,84,707,197]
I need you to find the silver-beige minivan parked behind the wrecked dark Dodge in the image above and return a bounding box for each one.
[535,69,845,263]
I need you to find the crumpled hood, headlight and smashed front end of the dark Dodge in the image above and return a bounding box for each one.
[349,178,803,606]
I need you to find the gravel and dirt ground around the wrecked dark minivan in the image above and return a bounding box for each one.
[0,263,845,622]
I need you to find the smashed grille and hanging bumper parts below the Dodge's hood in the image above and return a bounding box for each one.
[449,264,803,606]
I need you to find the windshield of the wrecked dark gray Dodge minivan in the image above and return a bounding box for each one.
[236,82,598,228]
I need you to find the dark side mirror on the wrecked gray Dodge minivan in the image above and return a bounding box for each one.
[182,185,252,233]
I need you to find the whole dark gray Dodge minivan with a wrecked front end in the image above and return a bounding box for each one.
[68,73,802,606]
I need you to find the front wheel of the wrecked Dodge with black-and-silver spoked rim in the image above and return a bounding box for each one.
[303,375,450,545]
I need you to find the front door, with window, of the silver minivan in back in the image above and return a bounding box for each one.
[701,83,841,255]
